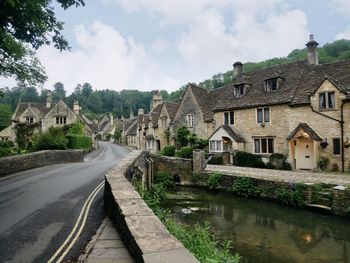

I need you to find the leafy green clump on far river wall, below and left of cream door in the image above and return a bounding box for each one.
[275,184,306,207]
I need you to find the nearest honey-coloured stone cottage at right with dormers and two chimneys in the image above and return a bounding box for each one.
[209,36,350,173]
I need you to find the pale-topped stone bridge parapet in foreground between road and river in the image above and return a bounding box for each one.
[104,151,198,263]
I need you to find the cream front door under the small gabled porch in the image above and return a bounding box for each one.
[295,139,315,170]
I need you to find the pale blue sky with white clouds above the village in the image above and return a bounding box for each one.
[0,0,350,93]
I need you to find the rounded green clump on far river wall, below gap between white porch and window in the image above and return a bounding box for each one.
[231,177,261,198]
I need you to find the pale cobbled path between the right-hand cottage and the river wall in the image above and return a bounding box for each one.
[206,165,350,187]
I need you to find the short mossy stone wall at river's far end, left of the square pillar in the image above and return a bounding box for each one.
[150,154,193,183]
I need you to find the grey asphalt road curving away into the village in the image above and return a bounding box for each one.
[0,143,129,263]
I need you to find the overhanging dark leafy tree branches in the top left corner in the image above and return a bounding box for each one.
[0,0,84,89]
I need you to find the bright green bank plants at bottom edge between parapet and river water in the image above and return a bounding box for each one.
[164,221,240,263]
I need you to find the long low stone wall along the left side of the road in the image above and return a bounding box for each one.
[0,150,84,176]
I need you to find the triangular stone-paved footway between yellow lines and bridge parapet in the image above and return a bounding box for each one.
[78,218,135,263]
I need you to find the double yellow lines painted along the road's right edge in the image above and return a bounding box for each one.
[47,181,104,263]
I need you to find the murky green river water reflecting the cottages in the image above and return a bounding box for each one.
[162,188,350,263]
